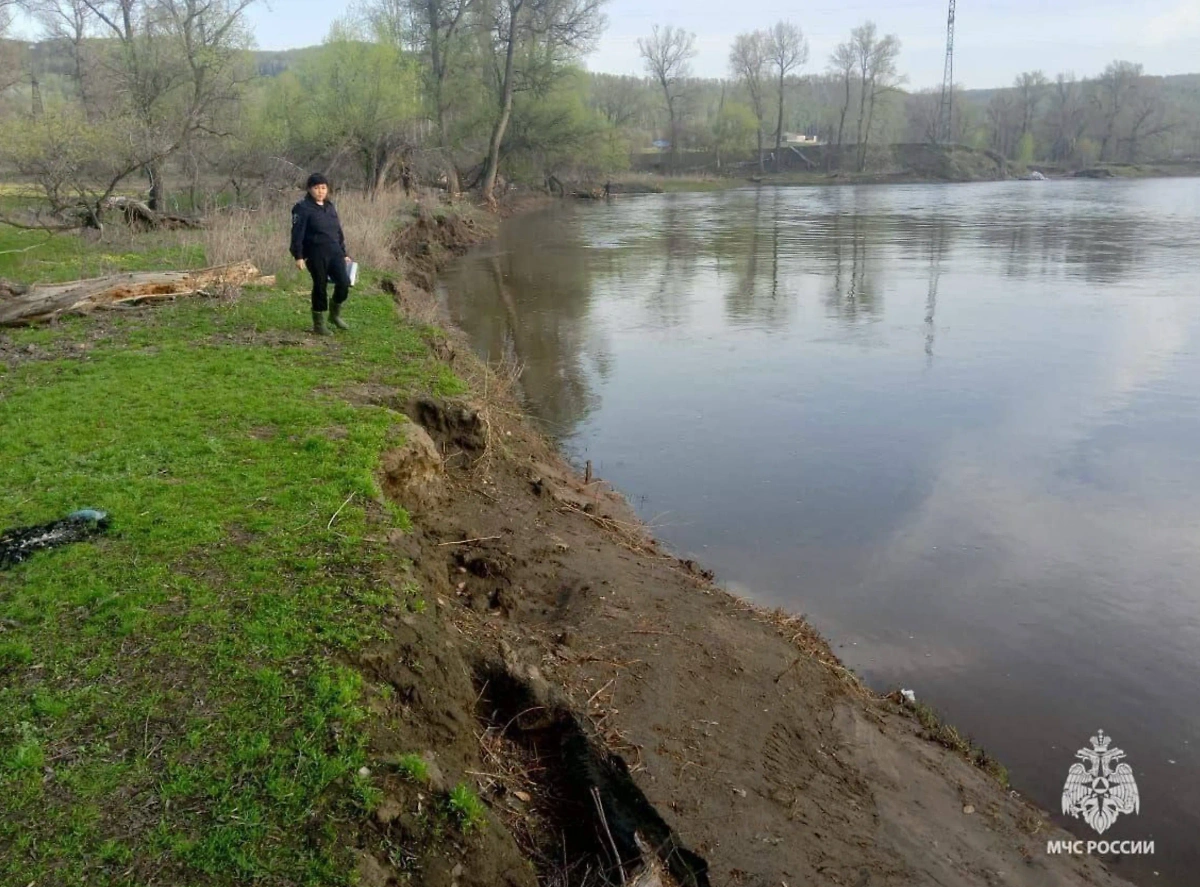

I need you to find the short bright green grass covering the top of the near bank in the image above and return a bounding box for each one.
[0,230,474,887]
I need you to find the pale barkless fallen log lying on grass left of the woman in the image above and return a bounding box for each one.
[0,262,271,326]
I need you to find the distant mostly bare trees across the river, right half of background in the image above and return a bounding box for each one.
[628,20,1200,172]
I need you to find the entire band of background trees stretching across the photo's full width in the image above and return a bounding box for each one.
[0,0,1200,225]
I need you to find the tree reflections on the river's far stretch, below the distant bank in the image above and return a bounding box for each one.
[450,182,1163,432]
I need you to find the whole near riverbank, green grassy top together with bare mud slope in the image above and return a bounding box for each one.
[0,205,1142,887]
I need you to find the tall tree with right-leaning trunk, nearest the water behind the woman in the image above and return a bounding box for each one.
[482,0,605,204]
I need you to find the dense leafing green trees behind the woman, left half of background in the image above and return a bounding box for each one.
[0,0,612,212]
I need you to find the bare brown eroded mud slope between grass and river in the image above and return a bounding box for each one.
[340,200,1142,887]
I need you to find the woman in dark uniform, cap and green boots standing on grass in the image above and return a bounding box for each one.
[292,173,350,336]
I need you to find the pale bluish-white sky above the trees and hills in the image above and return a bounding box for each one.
[18,0,1200,88]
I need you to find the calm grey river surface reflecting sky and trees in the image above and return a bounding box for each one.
[445,180,1200,887]
